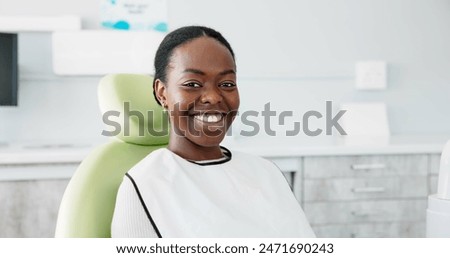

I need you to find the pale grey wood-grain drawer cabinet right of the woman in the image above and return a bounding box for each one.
[273,154,439,237]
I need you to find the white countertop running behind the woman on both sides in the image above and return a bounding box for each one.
[0,135,450,165]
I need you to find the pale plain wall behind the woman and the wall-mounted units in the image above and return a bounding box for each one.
[0,0,450,145]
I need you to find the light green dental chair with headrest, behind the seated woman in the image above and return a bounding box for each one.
[55,74,169,237]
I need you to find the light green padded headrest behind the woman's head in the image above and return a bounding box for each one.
[98,74,169,145]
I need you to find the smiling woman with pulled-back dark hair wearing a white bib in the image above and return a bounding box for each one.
[111,26,314,237]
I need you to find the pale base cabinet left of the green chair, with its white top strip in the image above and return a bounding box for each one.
[0,163,79,237]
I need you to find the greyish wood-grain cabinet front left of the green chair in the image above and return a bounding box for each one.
[0,179,69,237]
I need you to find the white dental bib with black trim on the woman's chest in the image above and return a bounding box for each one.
[113,148,314,237]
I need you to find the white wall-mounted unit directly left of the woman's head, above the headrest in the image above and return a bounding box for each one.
[52,30,165,75]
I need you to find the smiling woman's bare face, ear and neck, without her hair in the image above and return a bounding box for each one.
[155,36,239,160]
